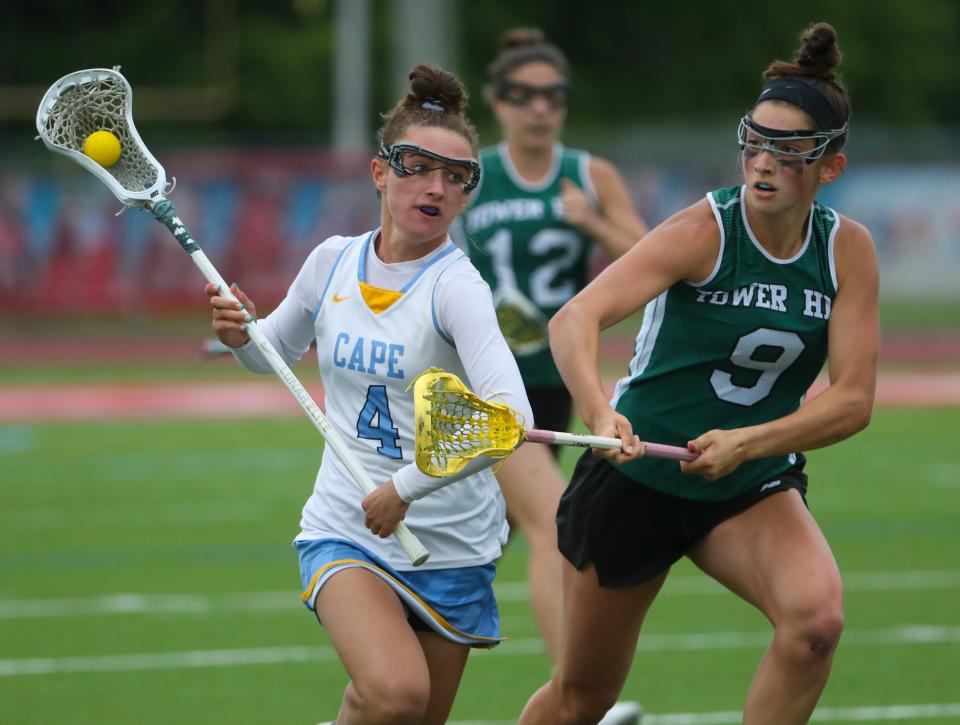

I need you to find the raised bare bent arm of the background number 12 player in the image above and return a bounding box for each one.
[562,156,649,259]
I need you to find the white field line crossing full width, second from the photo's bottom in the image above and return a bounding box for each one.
[0,625,960,677]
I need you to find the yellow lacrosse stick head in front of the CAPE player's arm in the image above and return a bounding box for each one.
[412,368,523,477]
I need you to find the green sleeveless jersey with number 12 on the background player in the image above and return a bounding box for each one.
[463,144,597,387]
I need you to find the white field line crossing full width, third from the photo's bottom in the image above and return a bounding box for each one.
[0,569,960,620]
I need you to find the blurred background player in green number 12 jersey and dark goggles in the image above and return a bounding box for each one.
[463,30,647,692]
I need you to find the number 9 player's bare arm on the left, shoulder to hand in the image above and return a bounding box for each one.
[549,200,720,462]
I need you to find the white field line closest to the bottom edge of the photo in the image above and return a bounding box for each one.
[448,702,960,725]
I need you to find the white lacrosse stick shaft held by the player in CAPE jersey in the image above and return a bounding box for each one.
[148,199,430,566]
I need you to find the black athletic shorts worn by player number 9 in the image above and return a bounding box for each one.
[557,450,807,587]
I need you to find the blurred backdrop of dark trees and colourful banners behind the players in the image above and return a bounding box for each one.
[0,0,960,314]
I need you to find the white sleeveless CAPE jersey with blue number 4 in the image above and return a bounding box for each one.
[297,233,507,570]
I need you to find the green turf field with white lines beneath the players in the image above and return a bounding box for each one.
[0,409,960,725]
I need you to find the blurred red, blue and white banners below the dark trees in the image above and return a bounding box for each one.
[0,157,960,313]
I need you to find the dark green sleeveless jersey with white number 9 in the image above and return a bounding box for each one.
[612,187,840,501]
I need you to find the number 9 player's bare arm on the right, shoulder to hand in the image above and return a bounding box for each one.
[681,219,880,480]
